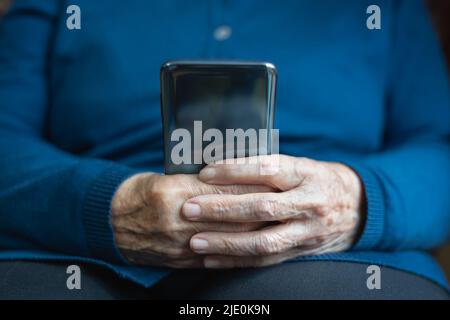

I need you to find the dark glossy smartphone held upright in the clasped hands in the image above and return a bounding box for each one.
[160,61,277,174]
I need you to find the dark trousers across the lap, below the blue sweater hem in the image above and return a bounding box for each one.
[0,261,449,300]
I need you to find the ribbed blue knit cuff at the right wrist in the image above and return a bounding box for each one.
[346,163,386,251]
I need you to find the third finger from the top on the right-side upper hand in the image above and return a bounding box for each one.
[190,221,311,256]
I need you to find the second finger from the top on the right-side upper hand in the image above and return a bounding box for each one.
[182,193,316,222]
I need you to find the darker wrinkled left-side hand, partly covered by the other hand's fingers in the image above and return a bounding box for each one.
[111,173,272,268]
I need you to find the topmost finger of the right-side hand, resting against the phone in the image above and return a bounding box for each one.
[199,155,304,190]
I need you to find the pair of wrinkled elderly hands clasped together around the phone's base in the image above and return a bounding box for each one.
[112,156,365,268]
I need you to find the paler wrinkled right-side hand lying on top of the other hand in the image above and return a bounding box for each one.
[182,155,365,268]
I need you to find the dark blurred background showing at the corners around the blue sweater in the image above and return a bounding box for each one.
[0,0,450,281]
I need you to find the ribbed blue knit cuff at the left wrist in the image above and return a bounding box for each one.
[83,166,136,264]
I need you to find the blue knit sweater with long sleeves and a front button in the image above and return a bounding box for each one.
[0,0,450,286]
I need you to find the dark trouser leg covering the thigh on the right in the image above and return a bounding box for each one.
[185,261,449,300]
